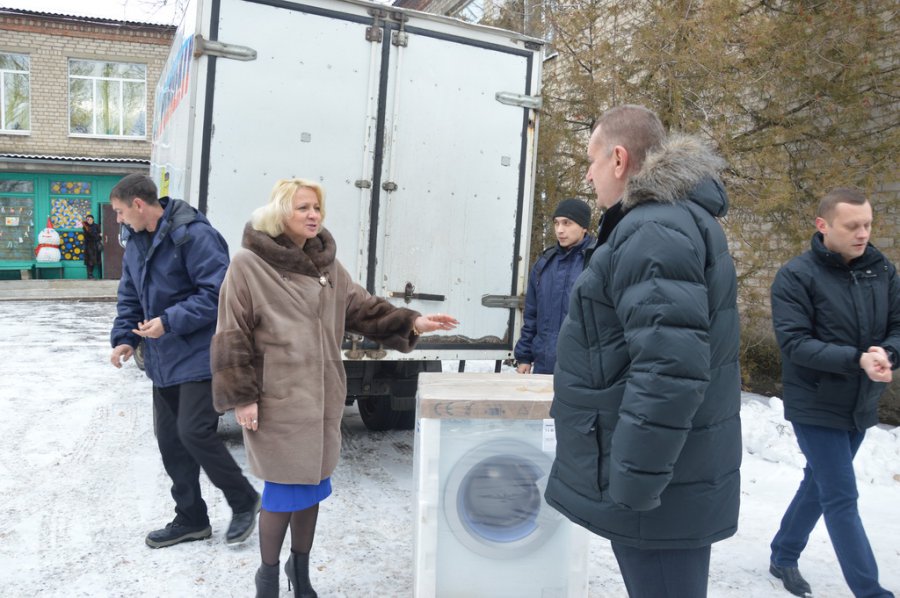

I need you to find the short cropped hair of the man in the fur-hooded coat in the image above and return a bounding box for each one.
[594,104,666,173]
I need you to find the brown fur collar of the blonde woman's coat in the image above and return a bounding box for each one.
[241,222,337,278]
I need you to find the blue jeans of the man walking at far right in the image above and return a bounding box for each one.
[772,423,893,598]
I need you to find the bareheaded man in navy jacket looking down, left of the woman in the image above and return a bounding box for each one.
[110,174,259,548]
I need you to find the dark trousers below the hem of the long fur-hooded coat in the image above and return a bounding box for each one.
[612,542,710,598]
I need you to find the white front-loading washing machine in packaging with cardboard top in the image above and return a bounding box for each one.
[414,373,588,598]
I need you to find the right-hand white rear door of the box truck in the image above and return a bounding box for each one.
[374,26,534,350]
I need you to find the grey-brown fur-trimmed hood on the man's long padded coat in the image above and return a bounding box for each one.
[622,133,728,217]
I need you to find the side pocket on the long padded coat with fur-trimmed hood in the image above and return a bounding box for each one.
[550,403,602,498]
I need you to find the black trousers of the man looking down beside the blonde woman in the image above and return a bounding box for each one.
[153,380,257,526]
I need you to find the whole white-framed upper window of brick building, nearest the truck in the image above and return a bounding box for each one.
[69,59,147,138]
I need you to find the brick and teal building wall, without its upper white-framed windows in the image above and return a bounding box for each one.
[0,9,175,279]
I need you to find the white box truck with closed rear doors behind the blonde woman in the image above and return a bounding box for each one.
[151,0,542,430]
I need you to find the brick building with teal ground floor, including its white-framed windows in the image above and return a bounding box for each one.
[0,7,175,279]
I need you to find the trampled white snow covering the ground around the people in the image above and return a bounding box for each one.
[0,302,900,598]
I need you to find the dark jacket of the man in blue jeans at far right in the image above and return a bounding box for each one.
[772,233,900,430]
